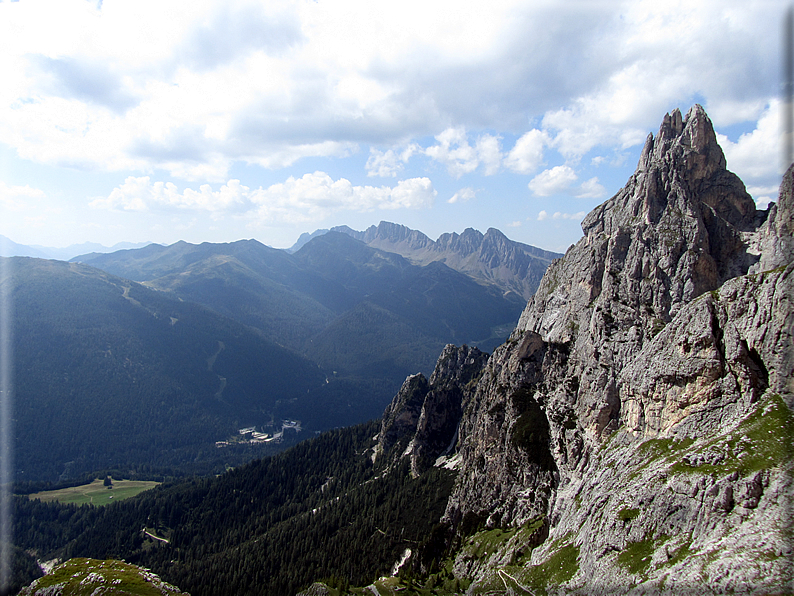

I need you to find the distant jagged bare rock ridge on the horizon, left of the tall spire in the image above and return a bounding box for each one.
[333,221,561,299]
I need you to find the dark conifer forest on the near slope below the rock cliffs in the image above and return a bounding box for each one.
[14,423,453,596]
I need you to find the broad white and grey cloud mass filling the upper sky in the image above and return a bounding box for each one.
[0,0,782,181]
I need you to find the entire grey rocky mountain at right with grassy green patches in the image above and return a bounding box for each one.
[380,106,794,594]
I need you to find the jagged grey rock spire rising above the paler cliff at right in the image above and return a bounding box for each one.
[518,106,758,354]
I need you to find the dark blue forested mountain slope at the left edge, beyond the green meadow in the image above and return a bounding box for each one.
[2,258,326,480]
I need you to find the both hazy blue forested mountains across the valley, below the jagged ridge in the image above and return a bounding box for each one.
[3,225,552,480]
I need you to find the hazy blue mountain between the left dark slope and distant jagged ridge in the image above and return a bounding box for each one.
[71,232,525,428]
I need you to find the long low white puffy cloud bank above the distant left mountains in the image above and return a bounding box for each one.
[96,172,437,222]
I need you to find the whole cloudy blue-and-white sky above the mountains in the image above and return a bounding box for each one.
[0,0,789,252]
